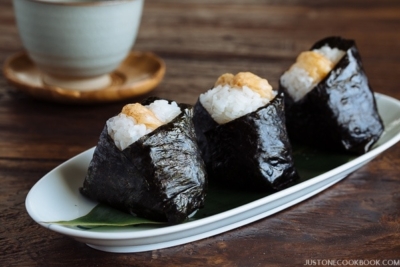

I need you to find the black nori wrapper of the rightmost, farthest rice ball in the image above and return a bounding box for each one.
[280,37,384,154]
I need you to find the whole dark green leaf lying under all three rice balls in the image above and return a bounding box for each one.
[47,144,355,228]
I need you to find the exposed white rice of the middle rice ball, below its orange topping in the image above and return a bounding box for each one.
[200,85,276,124]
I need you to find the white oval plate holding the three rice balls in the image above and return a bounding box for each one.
[25,94,400,253]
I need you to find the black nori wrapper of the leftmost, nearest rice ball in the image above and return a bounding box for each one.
[80,98,207,224]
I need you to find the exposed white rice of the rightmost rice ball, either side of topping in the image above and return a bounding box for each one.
[281,45,346,101]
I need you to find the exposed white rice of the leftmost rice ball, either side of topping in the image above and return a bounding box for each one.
[106,100,181,151]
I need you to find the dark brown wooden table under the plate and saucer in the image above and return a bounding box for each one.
[0,0,400,267]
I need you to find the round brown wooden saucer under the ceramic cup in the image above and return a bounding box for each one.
[3,51,165,104]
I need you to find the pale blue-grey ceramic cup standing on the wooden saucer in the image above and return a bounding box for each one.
[13,0,143,91]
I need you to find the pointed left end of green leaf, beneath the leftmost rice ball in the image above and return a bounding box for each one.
[51,204,165,229]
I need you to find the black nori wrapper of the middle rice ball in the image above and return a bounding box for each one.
[193,94,298,192]
